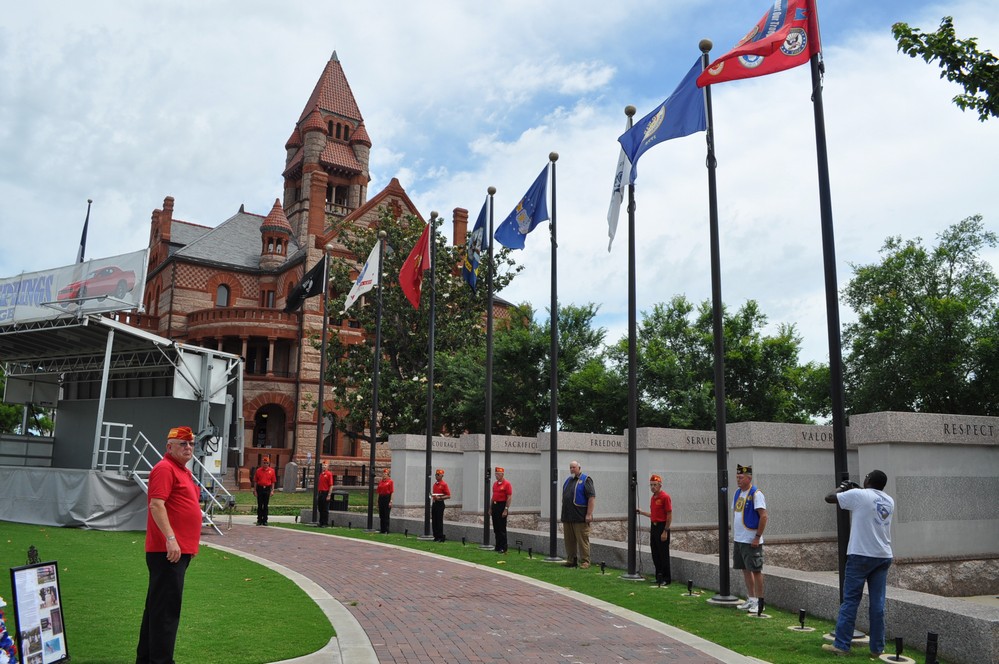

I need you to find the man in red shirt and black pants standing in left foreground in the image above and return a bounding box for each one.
[135,427,202,664]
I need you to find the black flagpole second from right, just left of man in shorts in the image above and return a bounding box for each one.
[698,39,739,603]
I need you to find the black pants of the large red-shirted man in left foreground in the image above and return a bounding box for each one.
[135,552,191,664]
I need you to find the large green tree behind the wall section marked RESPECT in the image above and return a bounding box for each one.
[844,215,999,415]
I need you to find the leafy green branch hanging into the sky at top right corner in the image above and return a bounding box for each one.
[891,16,999,122]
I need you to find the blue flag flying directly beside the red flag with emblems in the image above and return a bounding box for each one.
[617,58,708,182]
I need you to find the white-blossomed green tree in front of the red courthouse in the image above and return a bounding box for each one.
[324,209,521,435]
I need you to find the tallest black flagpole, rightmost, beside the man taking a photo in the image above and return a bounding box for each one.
[808,2,850,602]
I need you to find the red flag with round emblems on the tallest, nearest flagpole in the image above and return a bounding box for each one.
[697,0,821,88]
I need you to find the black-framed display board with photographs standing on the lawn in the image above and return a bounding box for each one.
[10,561,69,664]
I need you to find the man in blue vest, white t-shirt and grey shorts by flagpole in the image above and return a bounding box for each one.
[732,465,767,613]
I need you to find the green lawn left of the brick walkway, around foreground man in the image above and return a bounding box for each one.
[0,522,333,664]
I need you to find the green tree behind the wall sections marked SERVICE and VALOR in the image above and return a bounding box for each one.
[614,295,828,429]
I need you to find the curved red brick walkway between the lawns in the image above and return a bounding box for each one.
[204,525,756,664]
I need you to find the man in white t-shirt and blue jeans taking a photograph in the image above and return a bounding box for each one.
[822,470,895,657]
